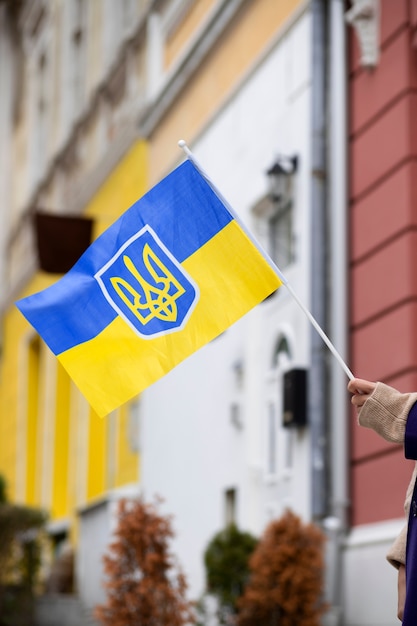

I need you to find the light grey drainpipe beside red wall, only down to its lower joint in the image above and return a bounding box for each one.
[329,0,349,527]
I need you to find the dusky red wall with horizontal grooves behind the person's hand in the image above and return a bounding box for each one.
[349,0,417,525]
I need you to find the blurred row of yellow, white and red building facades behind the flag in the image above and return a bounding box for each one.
[0,0,417,626]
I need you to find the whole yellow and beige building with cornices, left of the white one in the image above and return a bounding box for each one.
[0,0,306,604]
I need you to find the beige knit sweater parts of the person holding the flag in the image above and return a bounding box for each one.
[358,383,417,569]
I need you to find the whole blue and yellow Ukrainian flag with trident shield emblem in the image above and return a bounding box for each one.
[17,160,281,416]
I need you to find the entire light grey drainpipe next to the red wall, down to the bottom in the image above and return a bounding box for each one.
[324,0,349,626]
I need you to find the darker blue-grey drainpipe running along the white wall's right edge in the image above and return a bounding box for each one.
[308,0,329,522]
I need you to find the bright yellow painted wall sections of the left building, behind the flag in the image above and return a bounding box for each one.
[0,140,147,521]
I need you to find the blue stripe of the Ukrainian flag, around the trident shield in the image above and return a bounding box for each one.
[16,160,233,355]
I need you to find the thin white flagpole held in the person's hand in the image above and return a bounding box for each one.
[178,139,354,380]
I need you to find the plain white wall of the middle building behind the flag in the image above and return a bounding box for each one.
[142,8,310,598]
